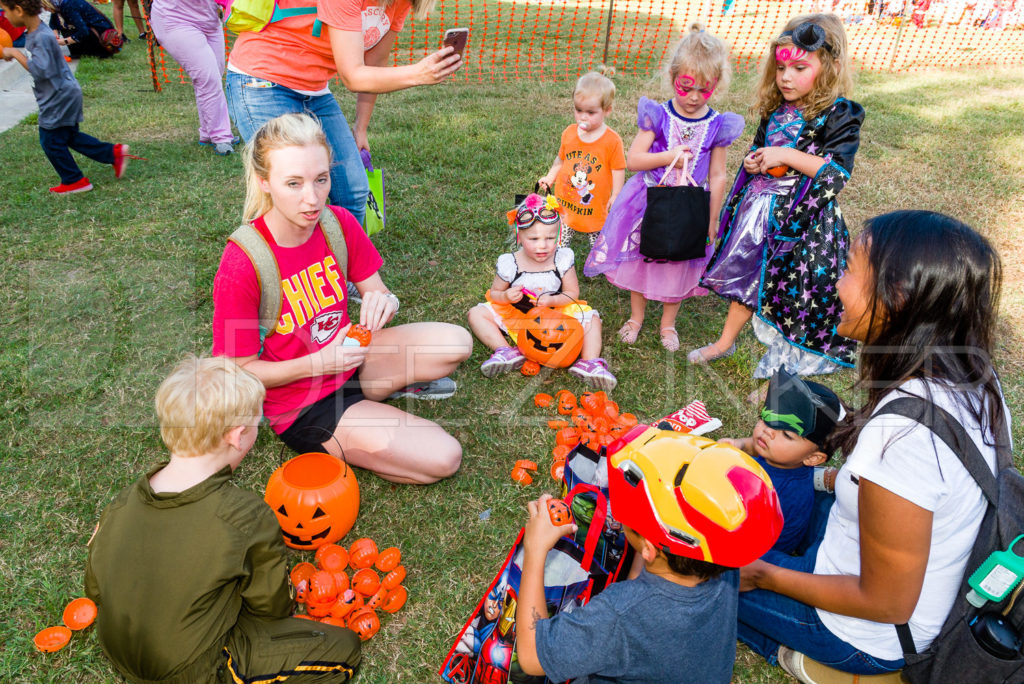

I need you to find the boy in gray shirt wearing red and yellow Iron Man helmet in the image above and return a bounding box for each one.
[513,427,782,684]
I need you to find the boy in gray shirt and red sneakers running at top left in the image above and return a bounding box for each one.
[0,0,132,195]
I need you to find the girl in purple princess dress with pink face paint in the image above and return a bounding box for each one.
[584,25,743,351]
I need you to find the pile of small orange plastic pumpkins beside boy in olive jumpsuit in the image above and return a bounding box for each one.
[291,538,409,641]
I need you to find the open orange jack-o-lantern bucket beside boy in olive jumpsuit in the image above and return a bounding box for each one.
[263,454,359,550]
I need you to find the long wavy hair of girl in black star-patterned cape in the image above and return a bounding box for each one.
[751,14,853,119]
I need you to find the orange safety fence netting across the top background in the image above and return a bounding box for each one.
[151,0,1024,90]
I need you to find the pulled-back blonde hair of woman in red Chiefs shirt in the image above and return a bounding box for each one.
[242,114,332,223]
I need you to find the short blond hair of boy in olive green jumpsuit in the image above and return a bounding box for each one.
[156,354,266,457]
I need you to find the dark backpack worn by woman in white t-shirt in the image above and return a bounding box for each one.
[877,397,1024,684]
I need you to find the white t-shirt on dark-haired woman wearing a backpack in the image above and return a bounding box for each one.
[814,380,1010,660]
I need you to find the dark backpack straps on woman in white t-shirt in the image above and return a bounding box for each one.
[871,396,1010,654]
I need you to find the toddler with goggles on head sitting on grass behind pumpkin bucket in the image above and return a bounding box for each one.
[469,195,618,391]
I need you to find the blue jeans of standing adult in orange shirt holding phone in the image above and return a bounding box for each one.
[225,71,370,224]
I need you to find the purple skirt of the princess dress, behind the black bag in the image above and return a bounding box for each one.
[583,172,714,302]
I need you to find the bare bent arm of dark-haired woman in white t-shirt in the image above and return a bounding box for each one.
[741,477,932,625]
